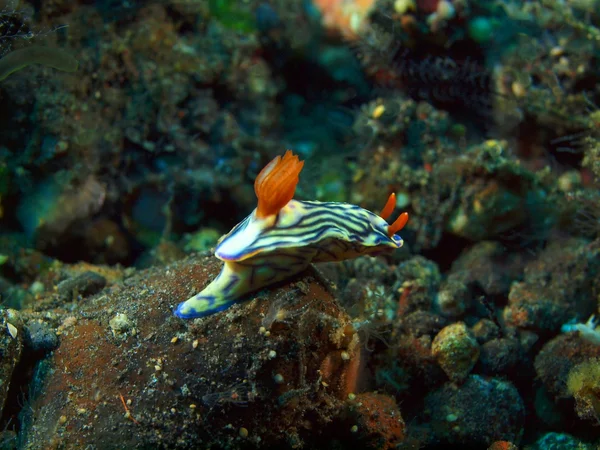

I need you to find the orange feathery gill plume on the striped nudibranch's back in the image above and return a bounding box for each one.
[254,150,304,219]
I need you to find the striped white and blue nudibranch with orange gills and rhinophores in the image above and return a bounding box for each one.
[175,150,408,319]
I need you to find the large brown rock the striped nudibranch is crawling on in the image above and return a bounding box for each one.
[24,258,382,448]
